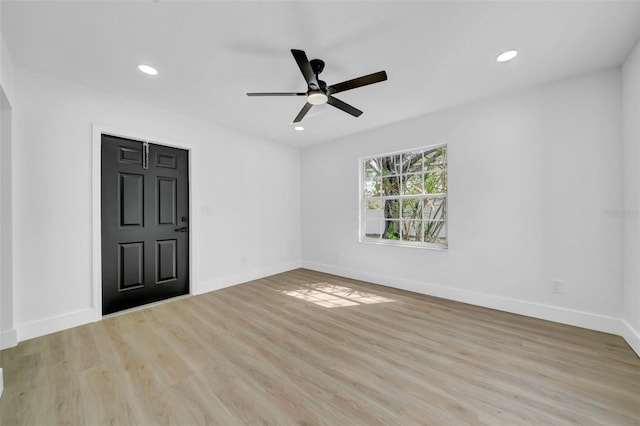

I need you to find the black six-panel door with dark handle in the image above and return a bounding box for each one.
[101,135,189,315]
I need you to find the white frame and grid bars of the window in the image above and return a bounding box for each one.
[358,142,449,250]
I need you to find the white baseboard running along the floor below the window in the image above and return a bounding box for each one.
[302,260,640,355]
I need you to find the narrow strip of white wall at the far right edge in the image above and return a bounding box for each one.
[621,43,640,352]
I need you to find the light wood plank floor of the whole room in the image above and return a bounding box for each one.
[0,270,640,426]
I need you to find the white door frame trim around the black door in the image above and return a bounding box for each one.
[91,123,199,321]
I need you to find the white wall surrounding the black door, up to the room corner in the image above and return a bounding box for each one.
[13,68,300,340]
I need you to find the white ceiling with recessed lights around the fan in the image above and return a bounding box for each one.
[1,0,640,147]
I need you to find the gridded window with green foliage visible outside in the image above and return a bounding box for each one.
[360,145,447,248]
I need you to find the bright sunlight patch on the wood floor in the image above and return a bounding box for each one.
[283,283,395,308]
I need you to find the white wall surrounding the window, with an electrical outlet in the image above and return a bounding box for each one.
[302,69,623,332]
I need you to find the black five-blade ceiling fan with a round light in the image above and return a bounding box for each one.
[247,49,387,123]
